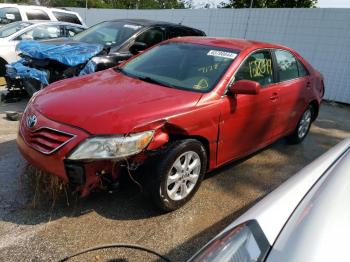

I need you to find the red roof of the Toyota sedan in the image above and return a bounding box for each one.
[169,36,290,51]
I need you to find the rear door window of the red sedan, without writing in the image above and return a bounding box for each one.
[275,50,299,82]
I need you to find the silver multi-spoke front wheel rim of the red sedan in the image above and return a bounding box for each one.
[167,151,201,201]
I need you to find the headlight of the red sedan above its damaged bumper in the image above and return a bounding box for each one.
[68,131,154,160]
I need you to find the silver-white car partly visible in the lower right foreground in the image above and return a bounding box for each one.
[190,138,350,262]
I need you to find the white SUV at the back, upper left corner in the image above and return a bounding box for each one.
[0,4,85,26]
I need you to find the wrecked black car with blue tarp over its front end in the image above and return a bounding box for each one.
[8,19,205,95]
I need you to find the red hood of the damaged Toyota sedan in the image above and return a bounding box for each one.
[33,69,202,134]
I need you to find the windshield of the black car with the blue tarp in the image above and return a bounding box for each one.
[73,22,142,46]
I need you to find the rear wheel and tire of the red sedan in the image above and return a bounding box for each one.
[287,105,314,144]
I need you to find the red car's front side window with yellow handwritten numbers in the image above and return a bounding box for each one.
[235,50,274,86]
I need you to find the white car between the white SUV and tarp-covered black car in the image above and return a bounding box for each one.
[0,21,86,77]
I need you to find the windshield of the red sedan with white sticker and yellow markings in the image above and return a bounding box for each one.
[121,43,237,93]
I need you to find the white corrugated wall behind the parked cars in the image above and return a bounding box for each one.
[72,8,350,104]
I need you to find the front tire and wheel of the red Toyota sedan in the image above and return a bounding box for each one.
[148,139,207,212]
